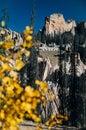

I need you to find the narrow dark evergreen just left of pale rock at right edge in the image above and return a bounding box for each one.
[69,37,77,126]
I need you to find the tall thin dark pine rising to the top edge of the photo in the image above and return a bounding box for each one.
[27,0,37,88]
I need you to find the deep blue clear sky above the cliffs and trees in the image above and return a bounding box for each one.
[0,0,86,32]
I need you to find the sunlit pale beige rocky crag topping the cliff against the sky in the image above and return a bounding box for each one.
[44,14,76,35]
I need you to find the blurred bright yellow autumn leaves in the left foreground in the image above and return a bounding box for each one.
[0,26,47,130]
